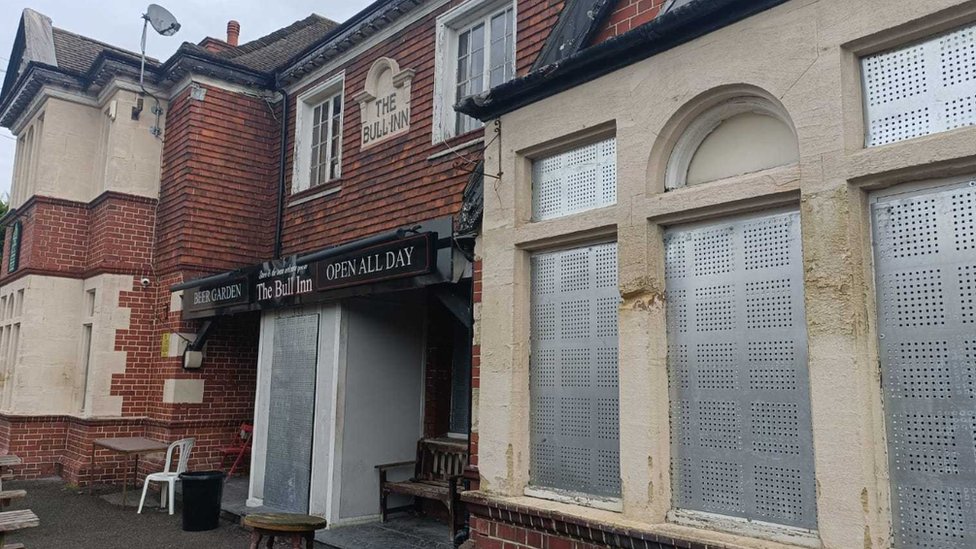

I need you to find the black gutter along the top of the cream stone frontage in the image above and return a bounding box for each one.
[454,0,789,121]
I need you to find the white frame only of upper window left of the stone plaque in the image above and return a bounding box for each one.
[291,72,348,194]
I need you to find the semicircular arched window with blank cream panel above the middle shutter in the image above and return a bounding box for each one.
[665,97,800,190]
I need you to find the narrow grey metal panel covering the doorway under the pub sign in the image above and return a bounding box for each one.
[264,315,319,513]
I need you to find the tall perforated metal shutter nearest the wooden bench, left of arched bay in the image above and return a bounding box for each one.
[529,243,620,497]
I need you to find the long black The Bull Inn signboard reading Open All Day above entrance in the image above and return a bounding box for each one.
[183,233,436,314]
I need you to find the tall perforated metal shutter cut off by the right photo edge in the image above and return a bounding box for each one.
[872,183,976,549]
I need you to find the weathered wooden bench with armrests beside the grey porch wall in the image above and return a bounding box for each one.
[376,439,468,540]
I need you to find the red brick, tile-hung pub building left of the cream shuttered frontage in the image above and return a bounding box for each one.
[0,0,659,540]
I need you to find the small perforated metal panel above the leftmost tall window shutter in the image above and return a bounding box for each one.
[532,137,617,221]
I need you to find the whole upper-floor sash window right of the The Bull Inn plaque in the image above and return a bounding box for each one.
[434,0,515,142]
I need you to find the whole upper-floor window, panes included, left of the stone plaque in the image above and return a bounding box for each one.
[292,74,344,192]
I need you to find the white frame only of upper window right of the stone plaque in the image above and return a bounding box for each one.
[431,0,518,145]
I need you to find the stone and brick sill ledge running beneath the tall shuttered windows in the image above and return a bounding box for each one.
[461,491,820,549]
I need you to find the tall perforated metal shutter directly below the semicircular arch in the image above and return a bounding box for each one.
[665,212,817,529]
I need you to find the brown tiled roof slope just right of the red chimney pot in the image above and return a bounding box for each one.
[217,14,339,71]
